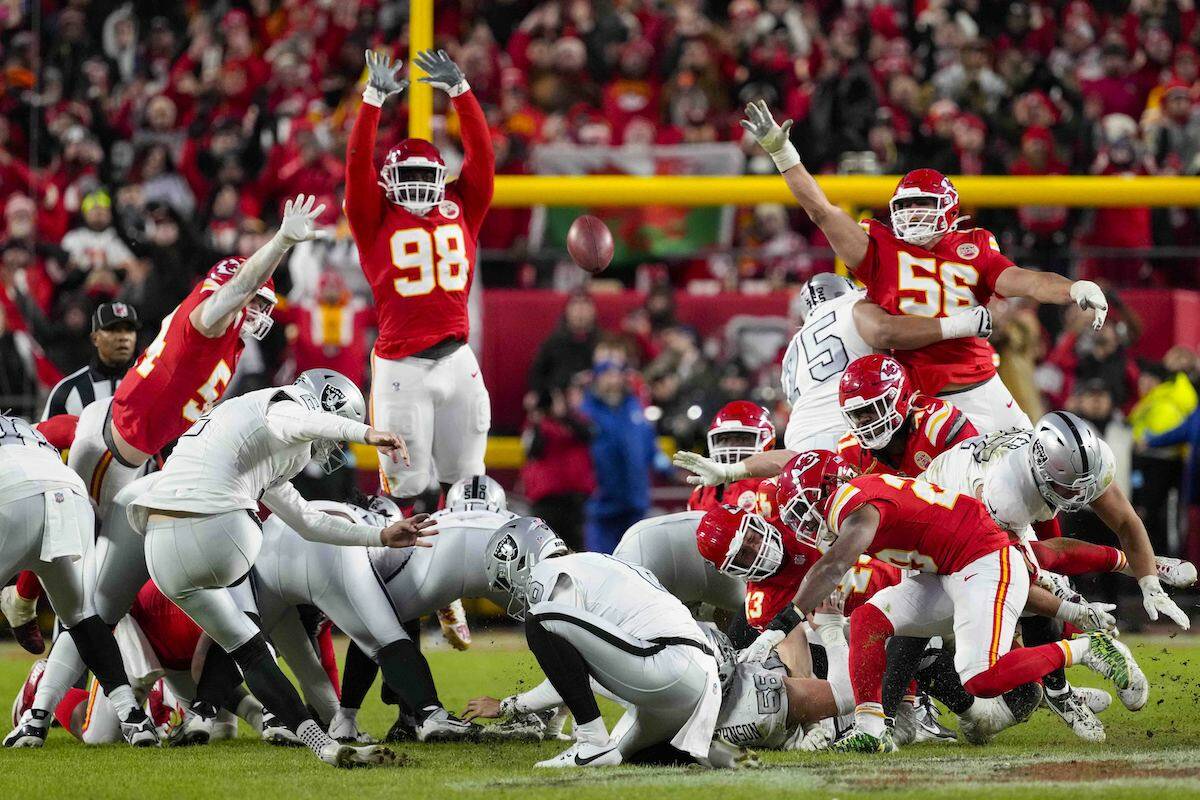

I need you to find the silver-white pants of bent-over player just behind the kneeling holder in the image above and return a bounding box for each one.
[612,511,746,613]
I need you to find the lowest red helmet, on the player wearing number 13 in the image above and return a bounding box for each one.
[696,505,784,581]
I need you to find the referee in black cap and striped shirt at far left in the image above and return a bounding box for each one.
[42,302,142,420]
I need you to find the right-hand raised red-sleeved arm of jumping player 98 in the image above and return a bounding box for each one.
[413,50,496,234]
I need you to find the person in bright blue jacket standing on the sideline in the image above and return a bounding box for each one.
[580,361,671,553]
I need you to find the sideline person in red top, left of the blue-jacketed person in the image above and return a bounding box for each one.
[521,385,596,551]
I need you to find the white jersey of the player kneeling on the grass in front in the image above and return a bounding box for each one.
[528,553,715,642]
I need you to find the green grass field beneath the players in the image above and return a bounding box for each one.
[0,631,1200,800]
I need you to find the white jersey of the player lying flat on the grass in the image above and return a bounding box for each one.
[716,656,791,750]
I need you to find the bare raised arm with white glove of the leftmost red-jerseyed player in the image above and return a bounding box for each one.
[191,194,325,338]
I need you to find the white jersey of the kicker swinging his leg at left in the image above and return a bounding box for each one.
[130,386,320,515]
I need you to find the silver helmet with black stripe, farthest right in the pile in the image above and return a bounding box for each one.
[1030,411,1116,511]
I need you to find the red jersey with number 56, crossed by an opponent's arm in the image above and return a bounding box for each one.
[854,219,1013,395]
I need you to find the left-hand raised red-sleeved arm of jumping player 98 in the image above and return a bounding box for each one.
[346,50,408,243]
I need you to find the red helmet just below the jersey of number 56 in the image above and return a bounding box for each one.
[838,354,913,450]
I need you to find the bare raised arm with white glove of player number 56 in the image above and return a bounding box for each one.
[742,100,870,270]
